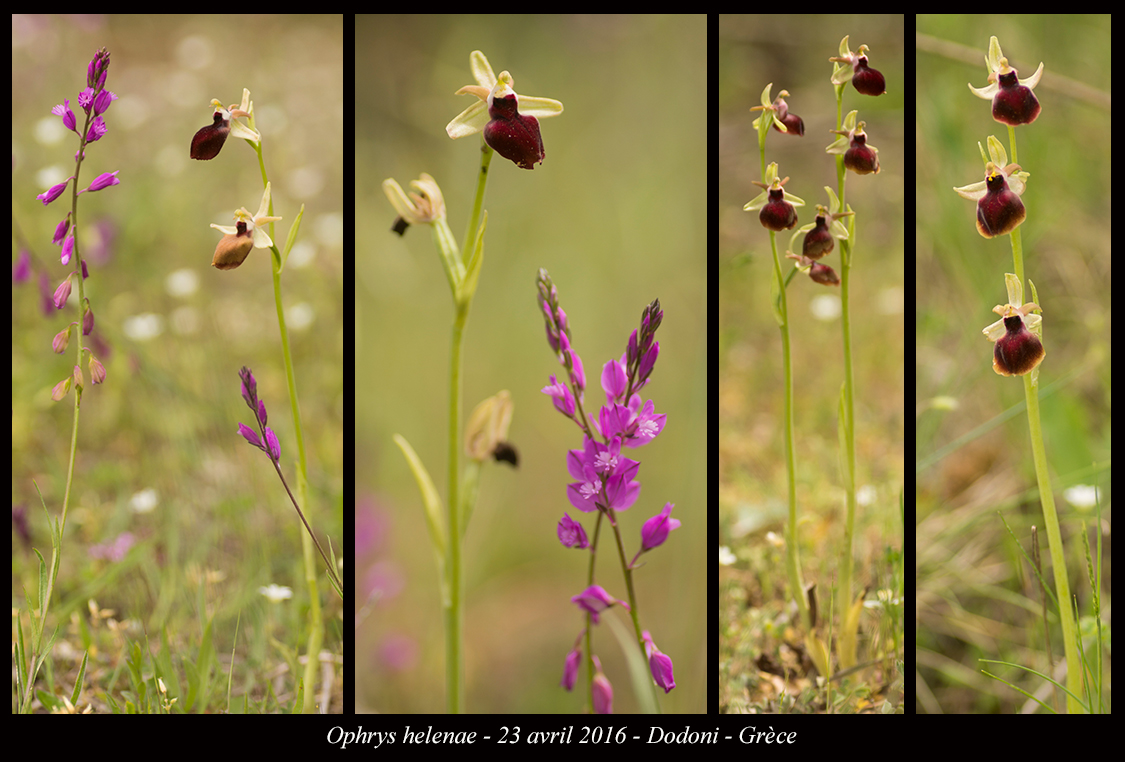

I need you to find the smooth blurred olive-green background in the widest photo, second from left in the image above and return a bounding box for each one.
[354,16,710,712]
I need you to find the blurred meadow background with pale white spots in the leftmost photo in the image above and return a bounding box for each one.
[12,15,350,711]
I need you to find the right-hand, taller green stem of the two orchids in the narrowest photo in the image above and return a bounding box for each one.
[836,84,855,669]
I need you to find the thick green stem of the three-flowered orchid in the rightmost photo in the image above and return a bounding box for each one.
[1008,126,1083,715]
